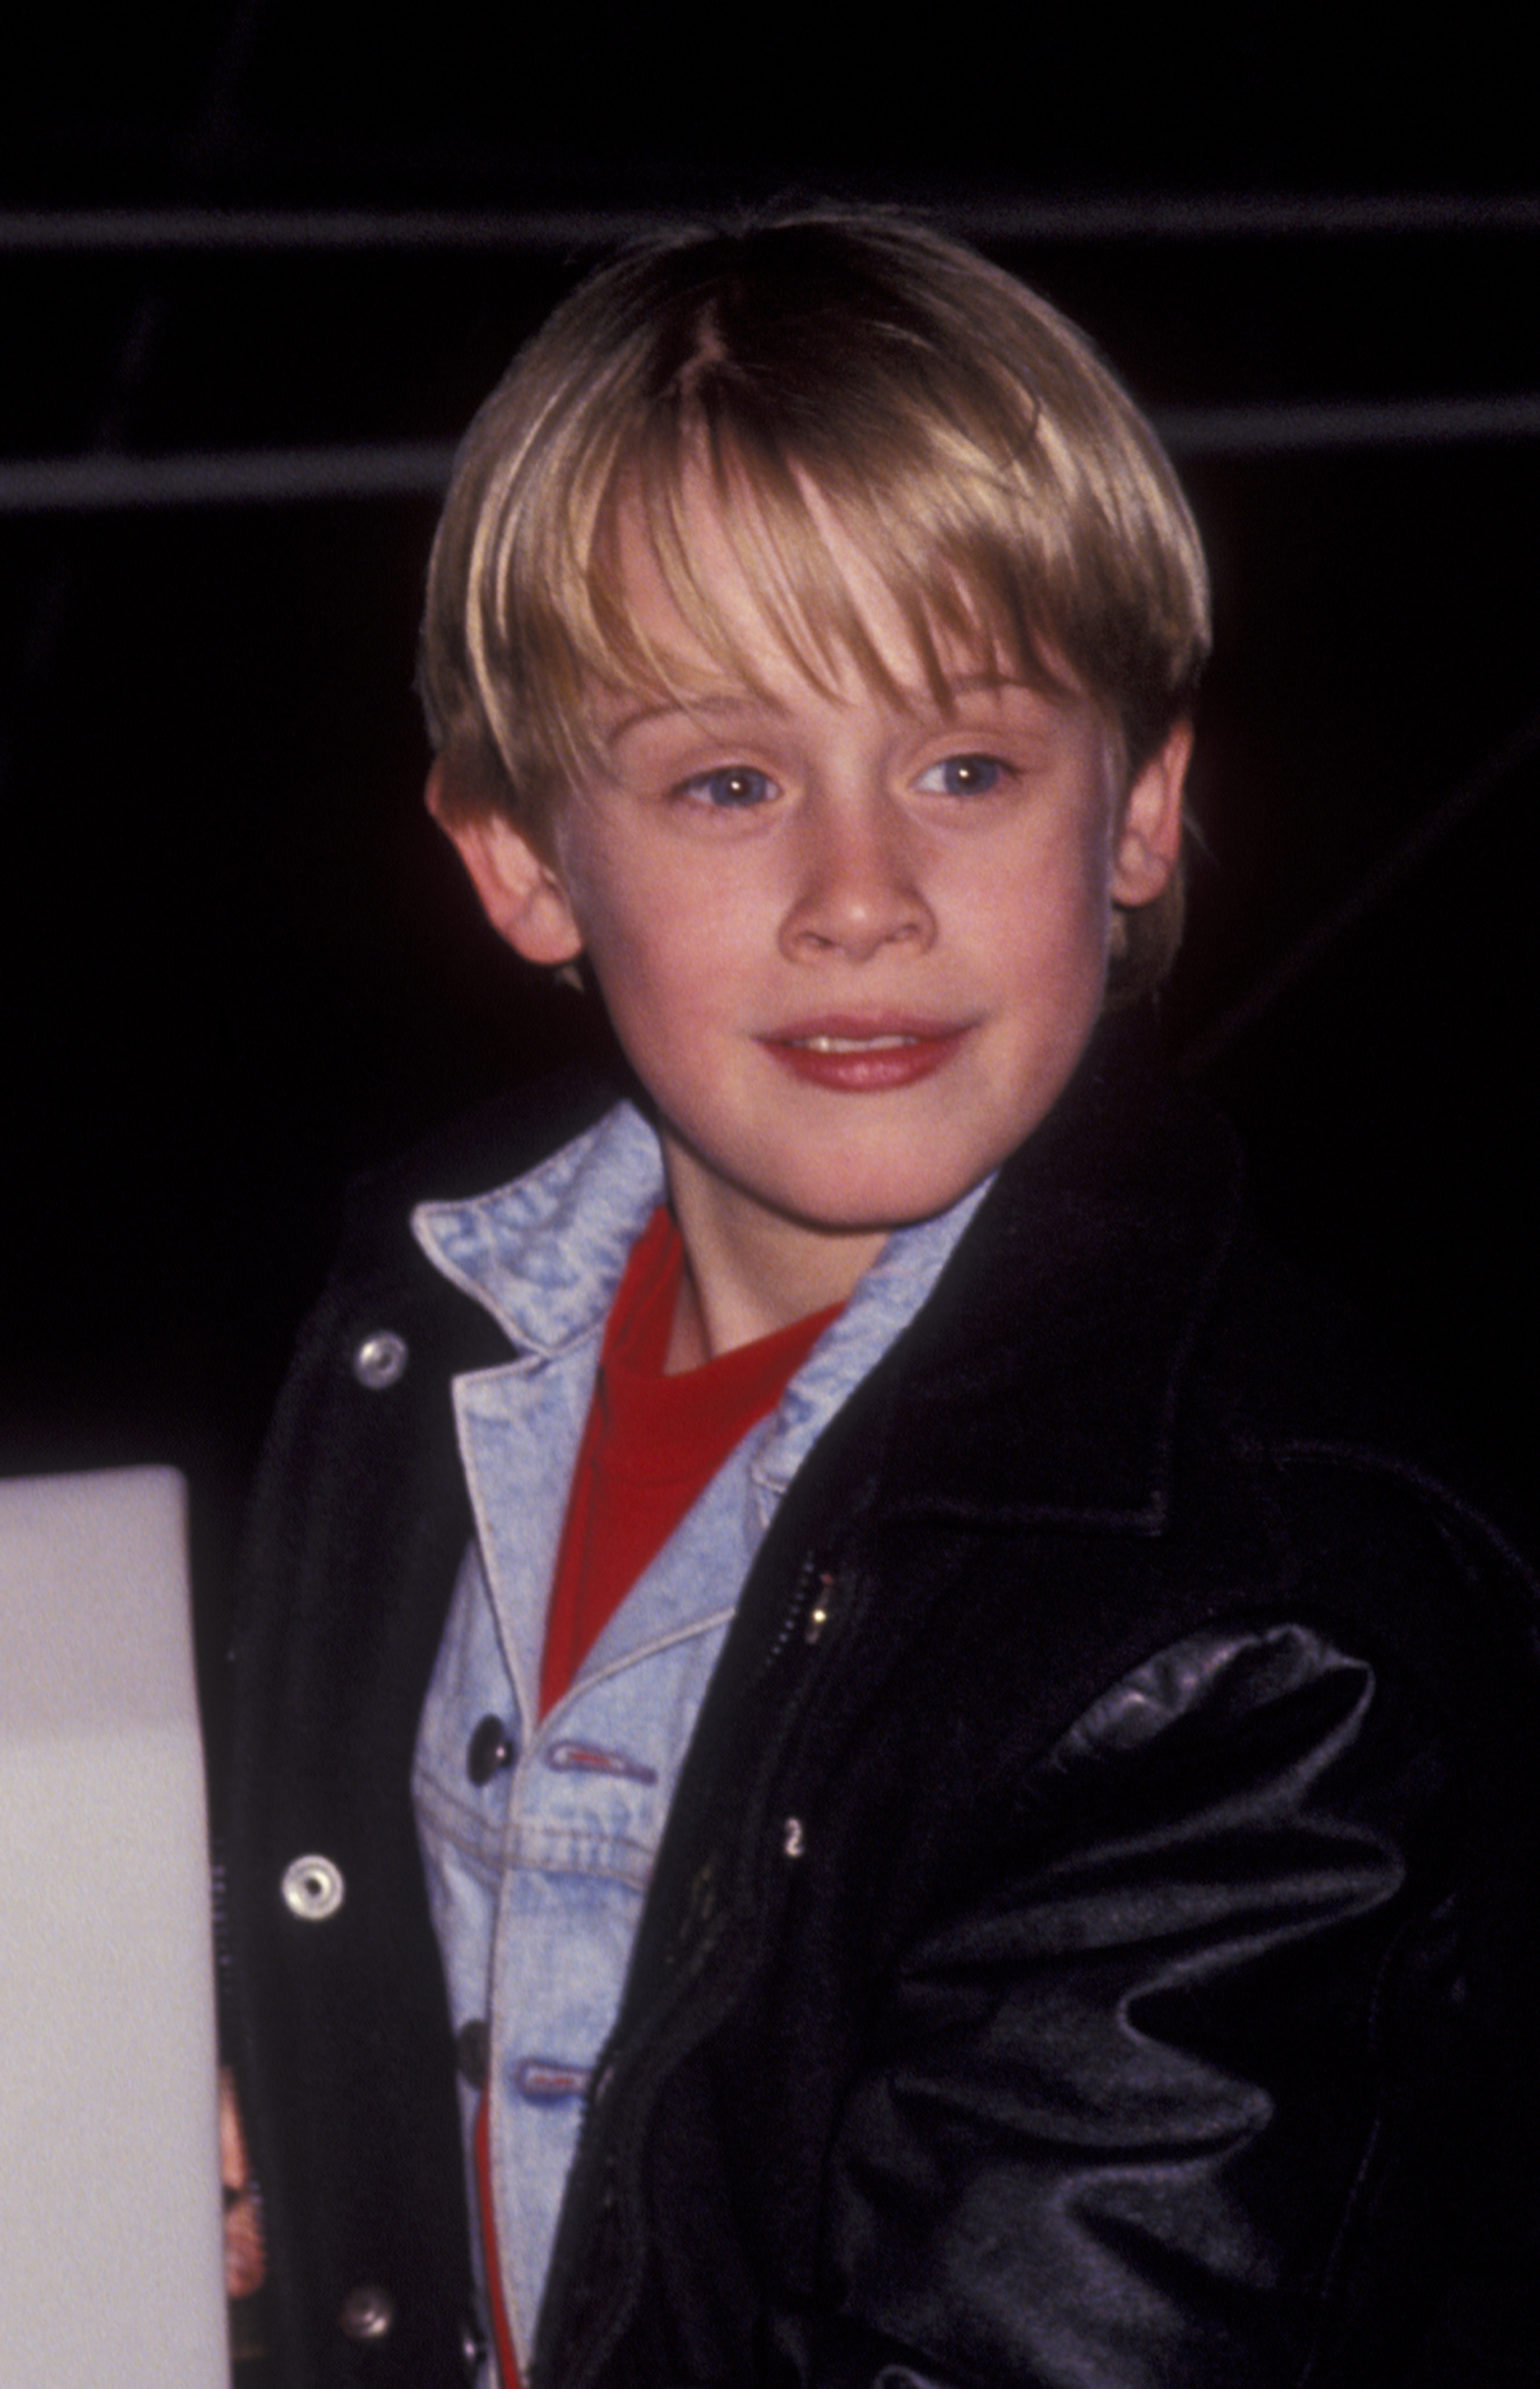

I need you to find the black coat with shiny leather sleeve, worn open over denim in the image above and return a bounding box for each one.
[232,1034,1540,2389]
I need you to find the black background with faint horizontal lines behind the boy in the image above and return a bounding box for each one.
[0,0,1540,1720]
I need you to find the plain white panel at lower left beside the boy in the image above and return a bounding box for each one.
[0,1469,229,2389]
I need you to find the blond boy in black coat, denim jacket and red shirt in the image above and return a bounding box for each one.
[232,215,1533,2389]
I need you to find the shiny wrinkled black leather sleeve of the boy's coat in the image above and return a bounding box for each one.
[807,1625,1435,2389]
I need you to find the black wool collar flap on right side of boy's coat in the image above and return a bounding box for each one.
[874,1020,1241,1534]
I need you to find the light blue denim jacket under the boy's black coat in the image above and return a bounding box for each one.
[413,1104,983,2367]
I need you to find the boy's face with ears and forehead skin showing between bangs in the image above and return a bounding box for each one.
[439,483,1186,1307]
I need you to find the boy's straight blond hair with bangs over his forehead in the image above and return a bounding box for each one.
[420,210,1208,991]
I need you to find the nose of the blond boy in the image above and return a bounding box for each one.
[780,793,936,963]
